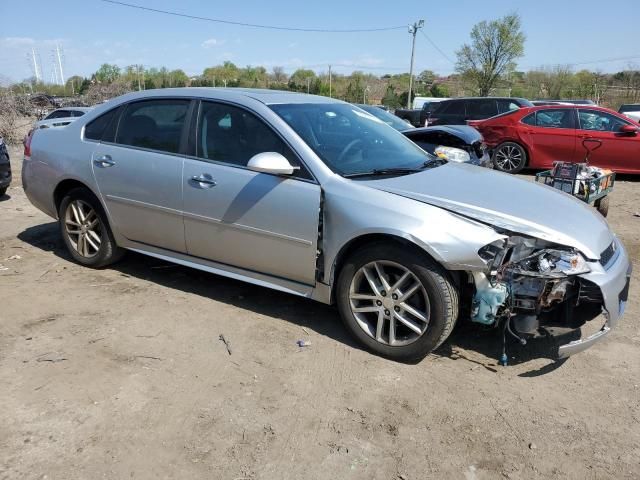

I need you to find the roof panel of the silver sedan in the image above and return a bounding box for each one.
[109,87,345,105]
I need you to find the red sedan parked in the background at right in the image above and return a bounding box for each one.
[468,105,640,173]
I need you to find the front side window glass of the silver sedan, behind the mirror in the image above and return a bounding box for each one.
[196,102,311,178]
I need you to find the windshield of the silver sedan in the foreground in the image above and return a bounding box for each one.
[271,103,434,176]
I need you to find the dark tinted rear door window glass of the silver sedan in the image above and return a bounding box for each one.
[116,100,190,153]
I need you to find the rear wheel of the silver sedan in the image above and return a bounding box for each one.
[58,188,124,268]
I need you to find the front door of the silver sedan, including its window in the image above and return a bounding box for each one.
[182,102,320,285]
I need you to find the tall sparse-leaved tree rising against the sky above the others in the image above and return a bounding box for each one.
[456,13,525,97]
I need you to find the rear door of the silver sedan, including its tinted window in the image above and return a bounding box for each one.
[92,100,189,252]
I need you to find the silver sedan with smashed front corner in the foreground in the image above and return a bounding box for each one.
[22,88,631,360]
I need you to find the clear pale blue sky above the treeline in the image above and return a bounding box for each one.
[0,0,640,82]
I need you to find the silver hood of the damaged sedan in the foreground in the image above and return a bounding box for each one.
[366,163,613,260]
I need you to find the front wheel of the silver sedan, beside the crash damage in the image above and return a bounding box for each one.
[336,243,458,361]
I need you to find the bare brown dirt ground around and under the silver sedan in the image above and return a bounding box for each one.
[0,143,640,480]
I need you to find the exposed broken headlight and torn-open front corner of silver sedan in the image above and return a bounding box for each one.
[471,235,608,361]
